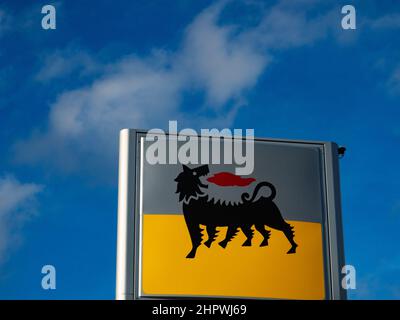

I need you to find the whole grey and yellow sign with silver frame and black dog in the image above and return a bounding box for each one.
[117,130,345,299]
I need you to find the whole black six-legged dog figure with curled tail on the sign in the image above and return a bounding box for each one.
[175,165,297,258]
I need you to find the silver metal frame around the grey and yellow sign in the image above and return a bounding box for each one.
[116,129,346,300]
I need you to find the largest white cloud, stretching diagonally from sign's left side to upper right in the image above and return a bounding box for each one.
[16,1,329,178]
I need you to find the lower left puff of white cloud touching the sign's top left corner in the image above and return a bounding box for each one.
[17,57,182,172]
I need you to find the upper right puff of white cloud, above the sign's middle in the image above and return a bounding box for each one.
[177,1,270,108]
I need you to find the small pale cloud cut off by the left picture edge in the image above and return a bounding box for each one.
[0,176,42,263]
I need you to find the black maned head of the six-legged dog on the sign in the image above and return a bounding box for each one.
[175,165,210,201]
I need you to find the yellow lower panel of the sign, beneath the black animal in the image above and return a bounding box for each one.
[142,214,325,299]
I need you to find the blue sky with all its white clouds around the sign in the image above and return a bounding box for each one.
[0,0,400,299]
